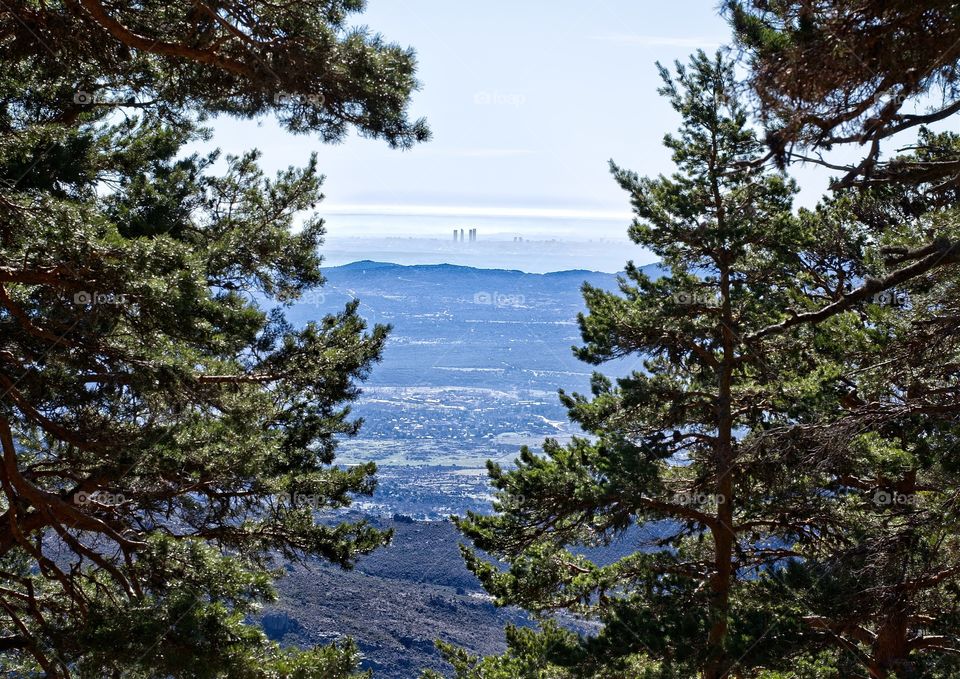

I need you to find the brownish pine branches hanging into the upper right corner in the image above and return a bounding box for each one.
[724,0,960,186]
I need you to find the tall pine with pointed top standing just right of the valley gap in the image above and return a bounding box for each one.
[458,53,858,678]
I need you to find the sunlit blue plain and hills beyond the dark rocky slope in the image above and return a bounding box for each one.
[288,261,656,518]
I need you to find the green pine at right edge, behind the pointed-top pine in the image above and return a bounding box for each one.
[753,154,960,679]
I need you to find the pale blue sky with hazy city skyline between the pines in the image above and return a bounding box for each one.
[204,0,840,268]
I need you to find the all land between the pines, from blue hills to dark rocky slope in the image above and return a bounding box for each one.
[262,261,657,679]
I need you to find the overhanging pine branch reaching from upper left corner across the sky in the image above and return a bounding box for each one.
[0,0,429,147]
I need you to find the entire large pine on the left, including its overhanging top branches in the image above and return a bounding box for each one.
[0,0,427,678]
